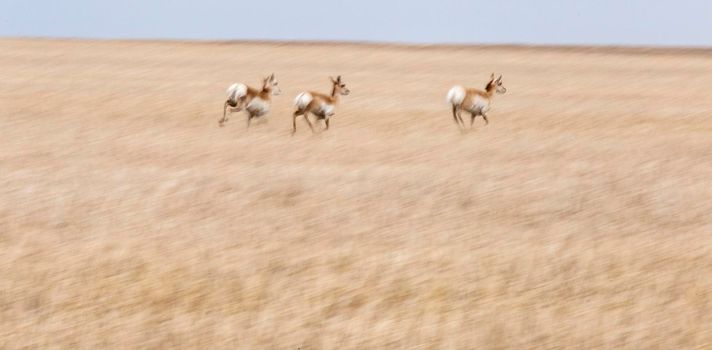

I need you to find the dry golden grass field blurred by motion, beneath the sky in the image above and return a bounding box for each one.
[0,39,712,349]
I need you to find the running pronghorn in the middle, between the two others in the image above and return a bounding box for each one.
[292,75,350,135]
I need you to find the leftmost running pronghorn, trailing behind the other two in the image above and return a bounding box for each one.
[219,73,282,128]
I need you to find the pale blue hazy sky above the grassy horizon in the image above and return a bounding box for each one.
[0,0,712,46]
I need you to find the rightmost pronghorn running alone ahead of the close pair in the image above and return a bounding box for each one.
[447,73,507,130]
